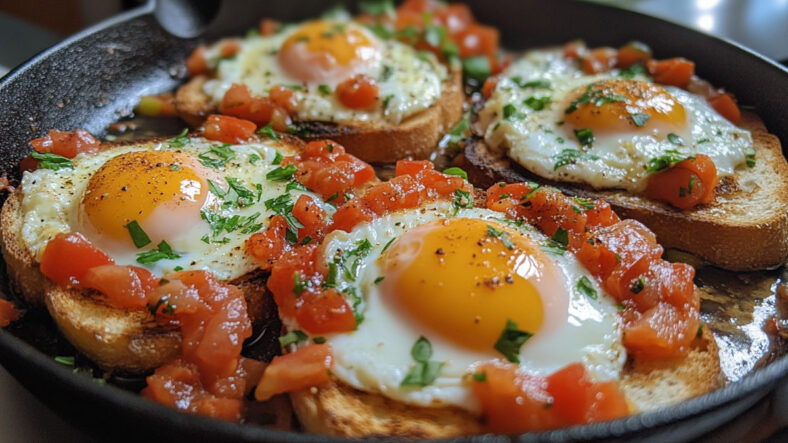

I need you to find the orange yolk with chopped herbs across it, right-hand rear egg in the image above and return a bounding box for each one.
[562,79,687,135]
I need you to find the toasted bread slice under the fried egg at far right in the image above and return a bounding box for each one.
[460,112,788,271]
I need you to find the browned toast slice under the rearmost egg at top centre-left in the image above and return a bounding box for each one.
[175,70,465,163]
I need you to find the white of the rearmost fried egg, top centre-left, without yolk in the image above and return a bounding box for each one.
[203,21,448,126]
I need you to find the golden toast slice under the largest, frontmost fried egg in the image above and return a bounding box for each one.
[290,328,725,439]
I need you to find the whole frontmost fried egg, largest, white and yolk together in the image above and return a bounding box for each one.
[285,202,626,411]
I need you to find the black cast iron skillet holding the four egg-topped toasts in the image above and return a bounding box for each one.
[0,0,788,441]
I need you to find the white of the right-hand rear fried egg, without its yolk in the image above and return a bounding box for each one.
[478,50,753,193]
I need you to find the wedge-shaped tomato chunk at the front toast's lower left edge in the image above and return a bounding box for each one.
[254,344,333,401]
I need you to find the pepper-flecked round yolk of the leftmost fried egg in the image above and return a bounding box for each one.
[82,151,214,247]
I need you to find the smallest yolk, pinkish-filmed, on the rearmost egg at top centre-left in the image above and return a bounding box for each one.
[278,20,378,82]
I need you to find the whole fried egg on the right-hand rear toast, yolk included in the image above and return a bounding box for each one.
[478,50,754,193]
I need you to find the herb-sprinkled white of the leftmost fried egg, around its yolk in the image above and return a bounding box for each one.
[20,137,334,280]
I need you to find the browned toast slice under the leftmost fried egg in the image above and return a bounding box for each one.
[0,137,296,372]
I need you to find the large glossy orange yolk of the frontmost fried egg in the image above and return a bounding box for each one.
[380,218,567,353]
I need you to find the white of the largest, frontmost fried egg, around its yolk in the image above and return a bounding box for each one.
[285,202,626,412]
